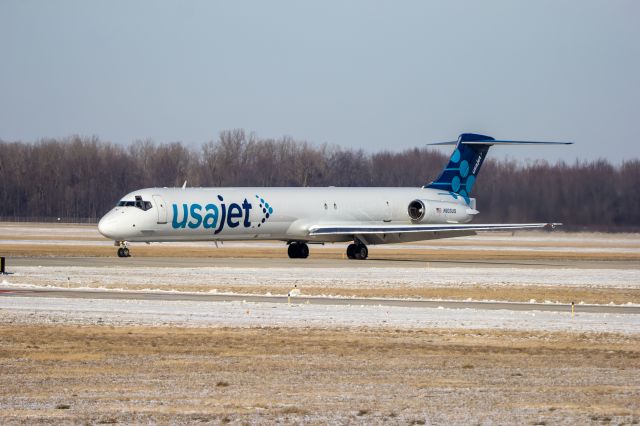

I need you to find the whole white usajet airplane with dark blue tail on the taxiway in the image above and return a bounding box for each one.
[98,133,572,260]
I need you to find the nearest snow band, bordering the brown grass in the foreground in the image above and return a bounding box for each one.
[0,297,640,334]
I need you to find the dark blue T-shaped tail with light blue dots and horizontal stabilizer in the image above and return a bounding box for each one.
[424,133,573,202]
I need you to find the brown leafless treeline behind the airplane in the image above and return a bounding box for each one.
[0,130,640,230]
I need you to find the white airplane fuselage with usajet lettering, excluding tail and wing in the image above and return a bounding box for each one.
[99,187,477,244]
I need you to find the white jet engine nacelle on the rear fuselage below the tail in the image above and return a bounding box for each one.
[407,198,478,223]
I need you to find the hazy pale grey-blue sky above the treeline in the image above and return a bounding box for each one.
[0,0,640,163]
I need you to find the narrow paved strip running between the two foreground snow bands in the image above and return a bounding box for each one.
[0,286,640,315]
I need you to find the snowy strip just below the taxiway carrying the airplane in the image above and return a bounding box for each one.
[6,266,640,291]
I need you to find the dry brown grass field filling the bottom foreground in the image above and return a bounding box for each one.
[0,324,640,425]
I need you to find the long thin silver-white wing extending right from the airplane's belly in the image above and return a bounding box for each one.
[309,223,562,236]
